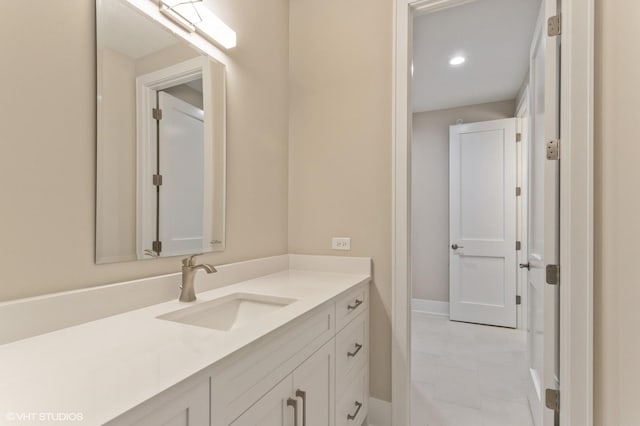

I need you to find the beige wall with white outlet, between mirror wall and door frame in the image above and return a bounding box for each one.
[289,0,393,400]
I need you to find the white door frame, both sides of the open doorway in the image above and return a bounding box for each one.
[391,0,594,426]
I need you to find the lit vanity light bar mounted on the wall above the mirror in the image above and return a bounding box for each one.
[159,0,236,49]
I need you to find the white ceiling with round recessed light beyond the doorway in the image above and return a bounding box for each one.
[412,0,540,112]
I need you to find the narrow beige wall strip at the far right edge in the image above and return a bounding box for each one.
[594,0,640,426]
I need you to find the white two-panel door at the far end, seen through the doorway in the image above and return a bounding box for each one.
[449,118,516,327]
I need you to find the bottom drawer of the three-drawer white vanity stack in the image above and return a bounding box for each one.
[336,365,369,426]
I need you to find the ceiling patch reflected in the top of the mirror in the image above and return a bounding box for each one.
[97,0,180,59]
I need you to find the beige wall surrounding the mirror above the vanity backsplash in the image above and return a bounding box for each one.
[0,0,289,300]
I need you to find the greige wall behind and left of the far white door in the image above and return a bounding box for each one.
[411,100,515,302]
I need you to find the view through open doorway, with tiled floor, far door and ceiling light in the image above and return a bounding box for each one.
[410,0,540,426]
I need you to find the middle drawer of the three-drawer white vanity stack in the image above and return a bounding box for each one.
[336,311,369,394]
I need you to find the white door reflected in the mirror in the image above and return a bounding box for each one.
[158,92,204,256]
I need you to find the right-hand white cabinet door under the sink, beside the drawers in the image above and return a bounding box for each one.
[293,339,335,426]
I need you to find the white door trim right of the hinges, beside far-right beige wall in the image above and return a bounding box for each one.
[560,0,594,426]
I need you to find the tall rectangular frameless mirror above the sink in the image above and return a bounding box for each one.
[96,0,225,263]
